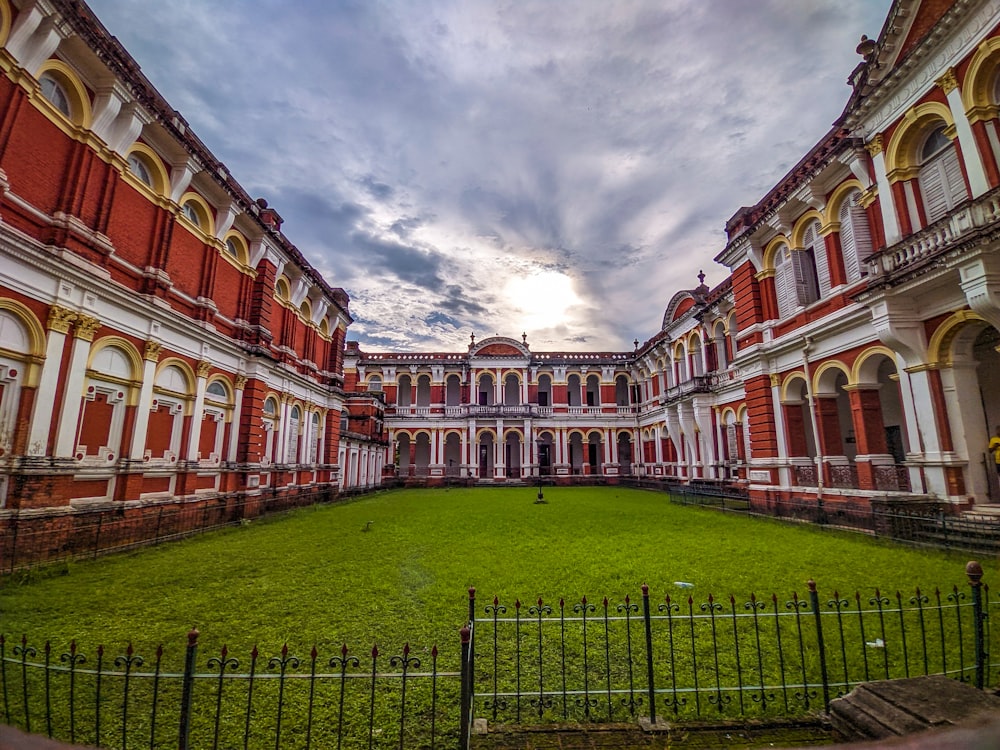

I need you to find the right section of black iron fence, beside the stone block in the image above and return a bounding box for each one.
[472,563,1000,725]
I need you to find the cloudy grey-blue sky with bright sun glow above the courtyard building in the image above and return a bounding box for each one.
[89,0,890,351]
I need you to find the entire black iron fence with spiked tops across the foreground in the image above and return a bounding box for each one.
[0,563,1000,750]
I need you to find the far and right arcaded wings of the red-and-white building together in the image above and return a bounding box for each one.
[347,0,1000,507]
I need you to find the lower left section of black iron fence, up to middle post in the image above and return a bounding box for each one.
[0,628,471,750]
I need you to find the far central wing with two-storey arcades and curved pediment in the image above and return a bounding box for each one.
[344,336,638,482]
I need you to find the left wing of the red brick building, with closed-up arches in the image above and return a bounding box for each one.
[0,0,360,544]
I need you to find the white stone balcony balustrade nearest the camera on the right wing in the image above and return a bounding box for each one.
[868,190,1000,283]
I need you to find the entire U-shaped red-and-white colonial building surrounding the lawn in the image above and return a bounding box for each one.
[0,0,1000,548]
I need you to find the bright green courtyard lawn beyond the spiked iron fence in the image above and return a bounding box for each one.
[0,487,984,654]
